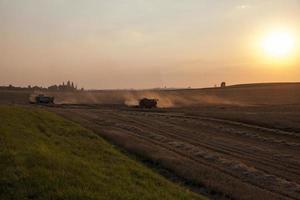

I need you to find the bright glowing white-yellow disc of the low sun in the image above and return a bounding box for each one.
[261,31,295,59]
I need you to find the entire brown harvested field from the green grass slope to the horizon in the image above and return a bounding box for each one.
[0,83,300,199]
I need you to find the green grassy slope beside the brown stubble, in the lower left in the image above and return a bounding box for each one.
[0,106,204,199]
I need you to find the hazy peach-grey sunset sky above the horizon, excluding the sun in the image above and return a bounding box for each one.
[0,0,300,88]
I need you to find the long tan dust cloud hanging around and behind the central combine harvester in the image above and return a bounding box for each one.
[42,90,240,108]
